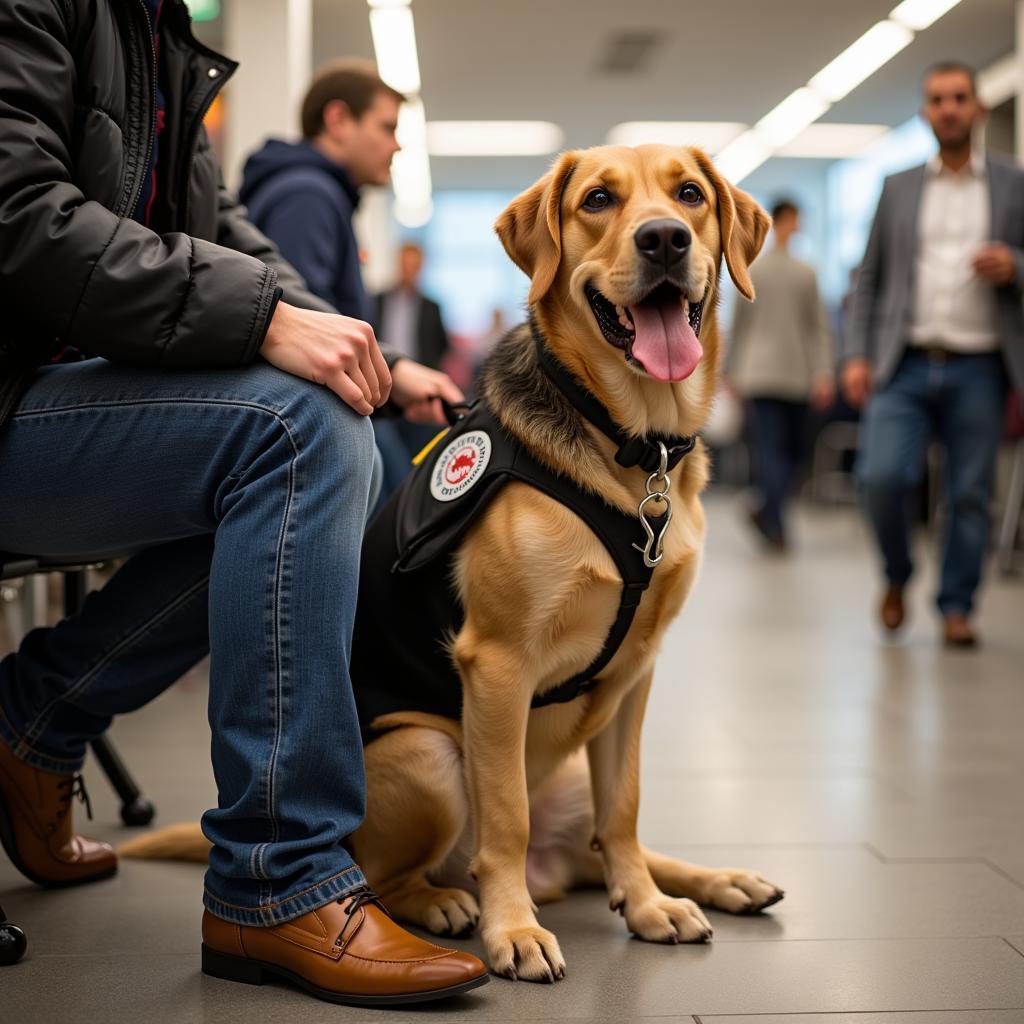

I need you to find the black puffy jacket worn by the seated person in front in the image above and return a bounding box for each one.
[0,0,331,425]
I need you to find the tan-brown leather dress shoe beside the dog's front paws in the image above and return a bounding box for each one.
[203,889,489,1007]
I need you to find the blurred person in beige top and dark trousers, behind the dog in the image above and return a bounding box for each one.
[725,200,836,551]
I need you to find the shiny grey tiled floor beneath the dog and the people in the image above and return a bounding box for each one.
[0,497,1024,1024]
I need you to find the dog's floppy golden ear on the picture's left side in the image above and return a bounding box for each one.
[495,153,579,305]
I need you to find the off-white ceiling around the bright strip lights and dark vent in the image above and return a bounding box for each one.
[203,0,1015,188]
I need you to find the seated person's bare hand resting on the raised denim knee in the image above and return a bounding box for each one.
[260,302,391,416]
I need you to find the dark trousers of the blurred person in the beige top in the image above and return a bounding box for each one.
[749,398,807,538]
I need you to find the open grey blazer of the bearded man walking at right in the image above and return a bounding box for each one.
[841,155,1024,392]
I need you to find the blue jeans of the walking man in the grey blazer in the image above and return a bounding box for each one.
[857,349,1007,614]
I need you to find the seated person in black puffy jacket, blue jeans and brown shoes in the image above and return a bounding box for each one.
[0,0,486,1009]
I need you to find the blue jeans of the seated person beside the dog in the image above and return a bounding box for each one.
[0,359,375,926]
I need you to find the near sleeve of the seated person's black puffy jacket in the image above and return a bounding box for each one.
[0,0,278,367]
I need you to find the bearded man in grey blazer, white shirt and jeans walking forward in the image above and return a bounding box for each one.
[841,61,1024,647]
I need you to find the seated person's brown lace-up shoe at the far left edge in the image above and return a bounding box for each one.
[0,741,118,886]
